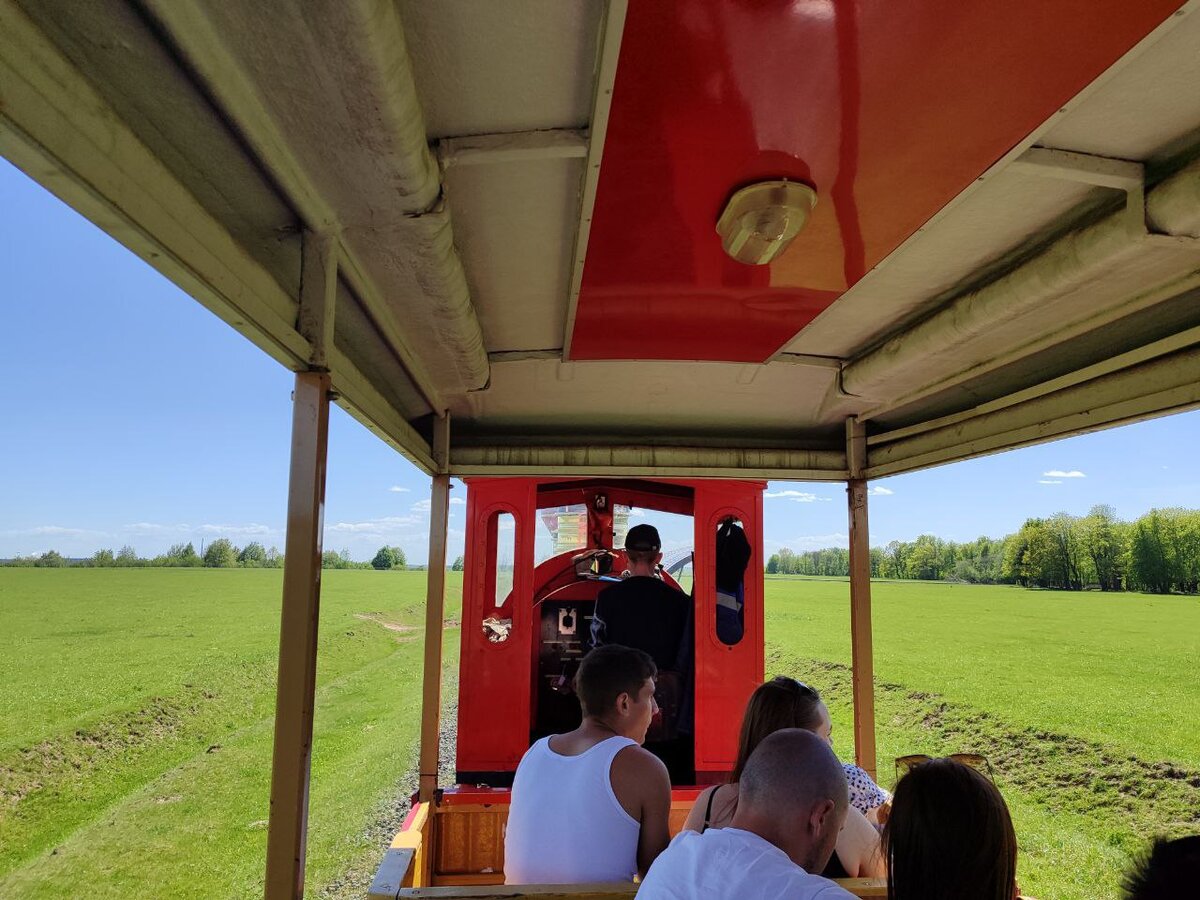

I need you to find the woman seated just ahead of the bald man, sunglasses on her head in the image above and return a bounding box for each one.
[684,676,883,878]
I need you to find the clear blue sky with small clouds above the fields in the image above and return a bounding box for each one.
[7,161,1200,560]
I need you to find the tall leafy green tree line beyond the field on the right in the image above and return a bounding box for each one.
[767,505,1200,594]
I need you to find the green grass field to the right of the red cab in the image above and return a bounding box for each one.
[767,578,1200,900]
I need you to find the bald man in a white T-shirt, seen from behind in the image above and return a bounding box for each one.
[637,728,854,900]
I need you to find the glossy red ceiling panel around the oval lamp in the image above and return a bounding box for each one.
[571,0,1180,362]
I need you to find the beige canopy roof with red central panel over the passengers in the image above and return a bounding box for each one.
[0,0,1200,480]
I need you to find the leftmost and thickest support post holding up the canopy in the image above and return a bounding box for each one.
[265,372,330,900]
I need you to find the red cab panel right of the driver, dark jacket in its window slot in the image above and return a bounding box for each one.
[694,481,764,784]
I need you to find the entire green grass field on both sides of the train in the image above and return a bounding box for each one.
[0,569,1200,900]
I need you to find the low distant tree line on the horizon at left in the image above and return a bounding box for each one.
[0,538,408,570]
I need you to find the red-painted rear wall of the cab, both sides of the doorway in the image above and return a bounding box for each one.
[457,478,766,775]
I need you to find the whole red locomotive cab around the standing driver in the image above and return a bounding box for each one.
[456,478,764,787]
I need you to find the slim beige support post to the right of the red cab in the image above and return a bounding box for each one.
[846,419,876,778]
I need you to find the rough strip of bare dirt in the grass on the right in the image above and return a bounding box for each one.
[768,650,1200,848]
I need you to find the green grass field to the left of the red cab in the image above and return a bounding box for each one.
[0,569,460,898]
